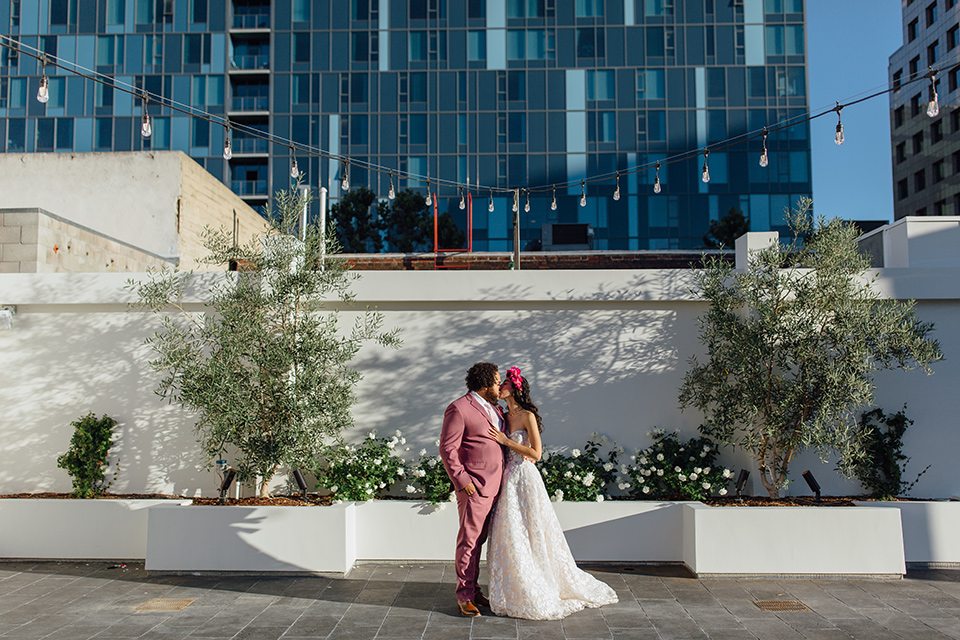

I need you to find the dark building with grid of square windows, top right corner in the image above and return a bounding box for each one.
[889,0,960,220]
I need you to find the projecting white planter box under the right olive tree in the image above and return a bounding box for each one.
[683,503,906,577]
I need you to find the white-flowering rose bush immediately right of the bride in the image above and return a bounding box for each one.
[537,433,623,502]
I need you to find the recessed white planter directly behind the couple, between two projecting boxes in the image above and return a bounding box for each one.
[356,500,684,563]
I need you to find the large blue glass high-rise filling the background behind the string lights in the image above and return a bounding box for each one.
[0,0,811,250]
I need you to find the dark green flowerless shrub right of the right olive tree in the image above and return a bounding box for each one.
[851,405,930,500]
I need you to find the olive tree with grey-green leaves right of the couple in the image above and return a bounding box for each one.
[680,199,942,497]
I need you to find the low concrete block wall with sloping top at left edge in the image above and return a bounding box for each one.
[0,209,170,273]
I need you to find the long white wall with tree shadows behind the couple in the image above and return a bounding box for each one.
[0,269,960,497]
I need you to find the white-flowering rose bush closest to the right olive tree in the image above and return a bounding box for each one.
[620,429,733,500]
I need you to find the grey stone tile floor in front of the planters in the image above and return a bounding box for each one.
[0,562,960,640]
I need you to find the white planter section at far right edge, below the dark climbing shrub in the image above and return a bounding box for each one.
[857,501,960,566]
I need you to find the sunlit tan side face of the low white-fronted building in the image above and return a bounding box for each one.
[179,156,266,270]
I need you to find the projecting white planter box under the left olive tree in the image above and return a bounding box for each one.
[146,503,356,573]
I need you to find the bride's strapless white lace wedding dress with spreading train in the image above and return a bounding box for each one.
[487,430,617,620]
